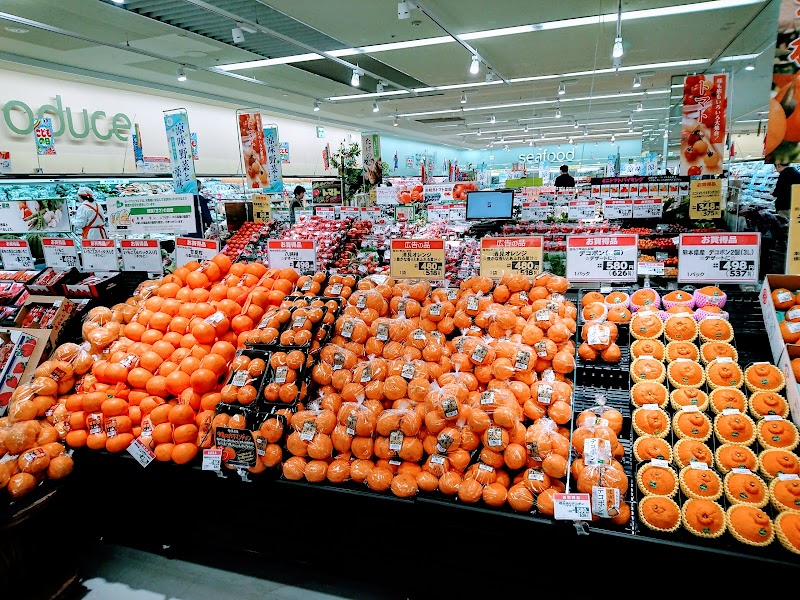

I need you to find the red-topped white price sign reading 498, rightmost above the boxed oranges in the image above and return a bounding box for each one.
[678,232,761,283]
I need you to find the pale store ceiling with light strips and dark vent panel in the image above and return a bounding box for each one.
[0,0,780,150]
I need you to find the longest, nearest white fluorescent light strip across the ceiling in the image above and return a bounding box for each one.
[219,0,764,71]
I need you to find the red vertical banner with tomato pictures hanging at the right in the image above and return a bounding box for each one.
[680,74,728,175]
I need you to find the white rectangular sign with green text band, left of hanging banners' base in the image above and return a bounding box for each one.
[106,194,197,235]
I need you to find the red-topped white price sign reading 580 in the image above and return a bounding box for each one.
[567,234,639,282]
